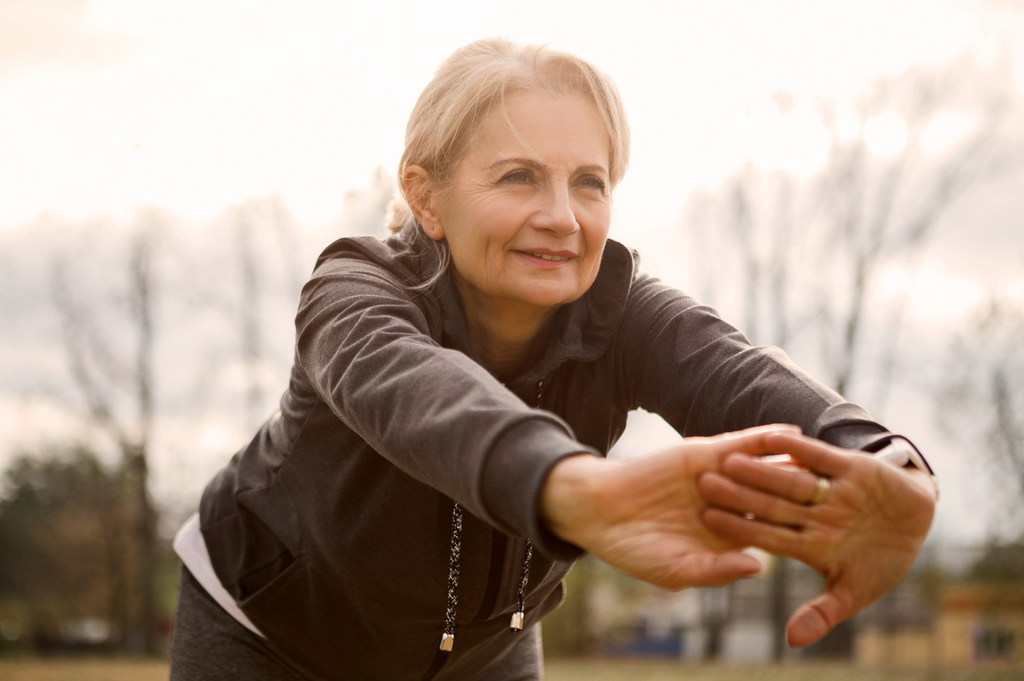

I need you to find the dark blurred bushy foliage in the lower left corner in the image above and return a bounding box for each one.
[0,445,176,653]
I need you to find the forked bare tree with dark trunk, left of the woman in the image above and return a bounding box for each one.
[51,211,166,652]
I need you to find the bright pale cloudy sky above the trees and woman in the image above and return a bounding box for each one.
[0,0,1024,537]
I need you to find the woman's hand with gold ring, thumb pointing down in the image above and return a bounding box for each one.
[698,433,937,647]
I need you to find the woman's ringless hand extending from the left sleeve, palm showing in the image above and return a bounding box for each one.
[540,425,799,590]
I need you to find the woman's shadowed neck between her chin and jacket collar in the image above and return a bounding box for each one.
[463,284,555,382]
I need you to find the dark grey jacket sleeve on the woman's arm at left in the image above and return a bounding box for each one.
[296,251,590,553]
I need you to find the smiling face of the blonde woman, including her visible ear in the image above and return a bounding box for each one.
[421,91,611,314]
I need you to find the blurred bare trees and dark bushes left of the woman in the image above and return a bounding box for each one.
[0,170,392,654]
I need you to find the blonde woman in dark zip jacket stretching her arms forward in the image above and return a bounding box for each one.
[171,40,934,680]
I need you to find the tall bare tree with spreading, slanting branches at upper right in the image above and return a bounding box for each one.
[815,59,1011,406]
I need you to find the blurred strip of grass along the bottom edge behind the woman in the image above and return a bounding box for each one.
[0,659,1024,681]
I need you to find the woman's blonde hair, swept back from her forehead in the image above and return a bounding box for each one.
[387,38,630,233]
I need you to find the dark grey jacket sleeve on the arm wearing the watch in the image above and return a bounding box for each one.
[617,275,892,451]
